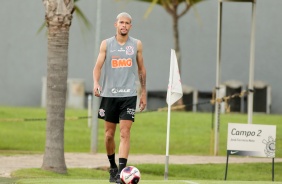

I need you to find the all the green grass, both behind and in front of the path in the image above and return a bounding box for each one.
[0,107,282,184]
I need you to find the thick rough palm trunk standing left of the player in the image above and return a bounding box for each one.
[41,0,74,173]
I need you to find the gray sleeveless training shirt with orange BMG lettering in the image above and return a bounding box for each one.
[101,36,138,97]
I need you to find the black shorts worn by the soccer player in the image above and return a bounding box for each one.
[98,96,137,123]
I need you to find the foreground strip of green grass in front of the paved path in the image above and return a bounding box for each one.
[9,163,282,182]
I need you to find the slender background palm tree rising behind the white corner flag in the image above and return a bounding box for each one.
[137,0,204,71]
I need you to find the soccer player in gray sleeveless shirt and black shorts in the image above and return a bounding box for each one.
[93,12,147,183]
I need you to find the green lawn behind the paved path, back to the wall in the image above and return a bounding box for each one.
[0,107,282,157]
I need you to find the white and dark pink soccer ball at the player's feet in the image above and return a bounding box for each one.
[120,166,141,184]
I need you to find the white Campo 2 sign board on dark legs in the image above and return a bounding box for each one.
[227,123,276,158]
